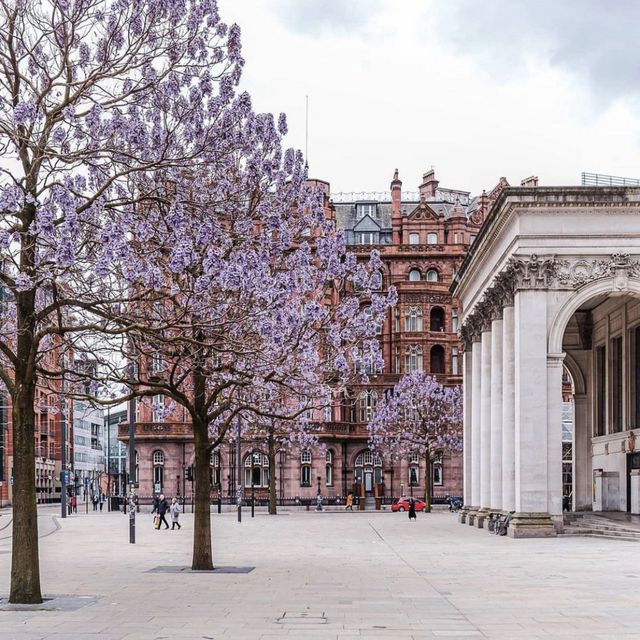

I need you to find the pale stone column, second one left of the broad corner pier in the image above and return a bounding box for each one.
[490,304,504,511]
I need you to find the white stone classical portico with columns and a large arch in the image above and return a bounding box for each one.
[452,187,640,537]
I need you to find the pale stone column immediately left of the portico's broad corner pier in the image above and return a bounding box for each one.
[502,299,516,511]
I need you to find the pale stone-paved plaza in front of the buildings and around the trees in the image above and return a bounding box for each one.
[0,509,640,640]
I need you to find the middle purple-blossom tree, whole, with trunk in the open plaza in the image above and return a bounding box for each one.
[121,178,395,569]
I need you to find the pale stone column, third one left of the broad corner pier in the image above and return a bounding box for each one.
[476,317,491,528]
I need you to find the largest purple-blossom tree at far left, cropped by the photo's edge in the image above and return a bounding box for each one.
[0,0,254,603]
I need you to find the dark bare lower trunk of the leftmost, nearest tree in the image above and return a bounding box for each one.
[9,290,42,604]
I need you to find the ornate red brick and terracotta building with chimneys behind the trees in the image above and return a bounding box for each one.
[119,170,489,506]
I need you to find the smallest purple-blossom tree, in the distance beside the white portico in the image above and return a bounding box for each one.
[367,372,462,511]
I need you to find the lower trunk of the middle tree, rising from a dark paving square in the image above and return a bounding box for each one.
[191,420,213,571]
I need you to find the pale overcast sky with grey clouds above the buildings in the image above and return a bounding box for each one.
[220,0,640,193]
